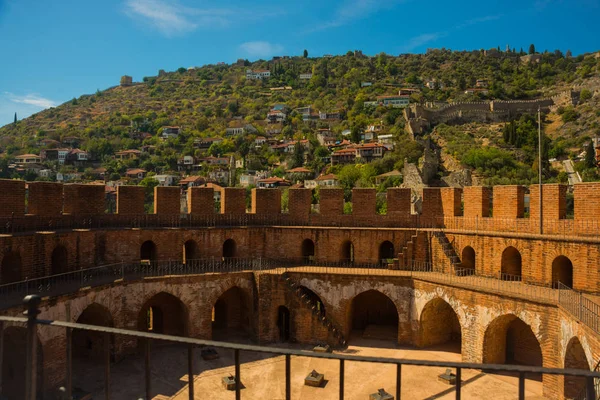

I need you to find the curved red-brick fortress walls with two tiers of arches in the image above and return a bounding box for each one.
[0,181,600,398]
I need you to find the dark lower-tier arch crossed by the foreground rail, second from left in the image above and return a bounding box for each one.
[72,303,114,364]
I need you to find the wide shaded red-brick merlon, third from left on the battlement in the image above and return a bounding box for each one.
[63,184,106,215]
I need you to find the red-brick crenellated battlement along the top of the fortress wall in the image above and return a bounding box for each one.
[0,180,600,234]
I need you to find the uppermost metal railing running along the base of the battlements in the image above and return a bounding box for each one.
[0,213,600,240]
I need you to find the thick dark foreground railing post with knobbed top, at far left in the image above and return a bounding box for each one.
[23,294,42,400]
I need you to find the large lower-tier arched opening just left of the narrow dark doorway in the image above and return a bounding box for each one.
[212,286,251,340]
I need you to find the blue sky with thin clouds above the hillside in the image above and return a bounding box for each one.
[0,0,600,126]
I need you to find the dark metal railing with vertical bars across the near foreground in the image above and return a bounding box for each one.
[8,295,600,400]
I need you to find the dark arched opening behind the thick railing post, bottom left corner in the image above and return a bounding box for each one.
[0,326,44,400]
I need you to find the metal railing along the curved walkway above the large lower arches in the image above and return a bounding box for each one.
[0,257,600,333]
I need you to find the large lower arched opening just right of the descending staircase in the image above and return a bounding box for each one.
[350,290,398,341]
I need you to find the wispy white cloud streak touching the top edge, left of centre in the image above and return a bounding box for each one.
[125,0,281,37]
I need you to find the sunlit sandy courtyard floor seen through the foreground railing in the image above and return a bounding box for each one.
[73,335,544,400]
